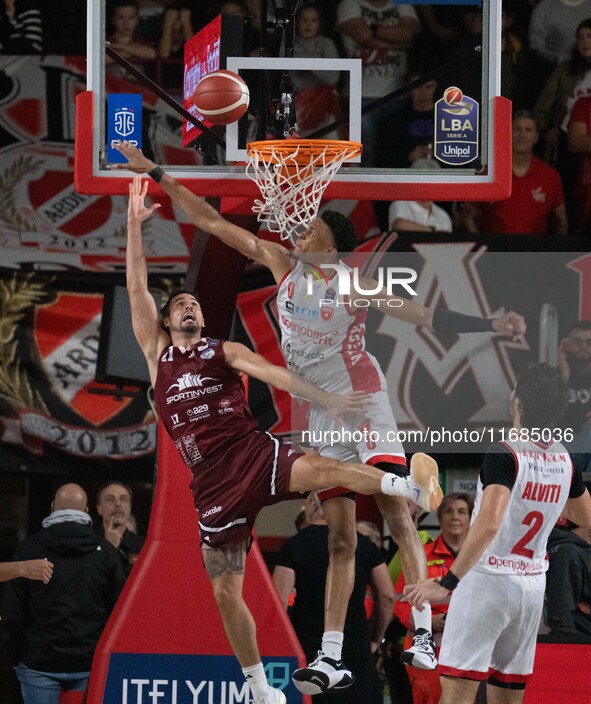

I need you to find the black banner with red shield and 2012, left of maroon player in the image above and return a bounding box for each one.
[0,270,183,476]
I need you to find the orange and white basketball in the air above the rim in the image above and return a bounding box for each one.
[193,70,250,125]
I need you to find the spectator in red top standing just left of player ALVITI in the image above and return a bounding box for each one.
[394,492,473,704]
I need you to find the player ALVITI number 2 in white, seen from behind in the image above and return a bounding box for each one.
[404,364,591,704]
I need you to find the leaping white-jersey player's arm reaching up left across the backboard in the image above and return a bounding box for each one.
[113,142,290,283]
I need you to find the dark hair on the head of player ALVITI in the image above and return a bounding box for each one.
[515,364,568,428]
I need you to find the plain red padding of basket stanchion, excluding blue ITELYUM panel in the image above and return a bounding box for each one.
[87,426,305,704]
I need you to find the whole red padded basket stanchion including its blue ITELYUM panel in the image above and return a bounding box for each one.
[87,420,305,704]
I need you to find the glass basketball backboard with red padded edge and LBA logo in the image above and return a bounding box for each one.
[76,0,511,200]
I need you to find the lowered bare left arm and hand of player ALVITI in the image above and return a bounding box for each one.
[404,484,511,611]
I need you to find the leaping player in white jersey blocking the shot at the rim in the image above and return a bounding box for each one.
[114,142,525,694]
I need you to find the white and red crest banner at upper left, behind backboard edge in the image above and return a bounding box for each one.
[0,56,197,272]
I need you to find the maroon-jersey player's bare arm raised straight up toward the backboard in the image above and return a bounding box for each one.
[125,176,169,384]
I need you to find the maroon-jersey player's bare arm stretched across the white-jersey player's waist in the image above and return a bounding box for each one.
[224,342,367,423]
